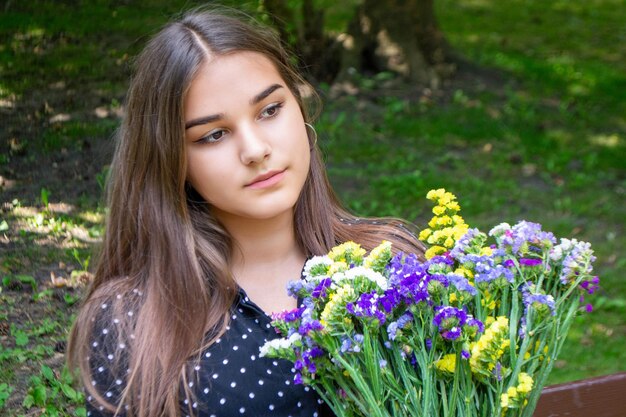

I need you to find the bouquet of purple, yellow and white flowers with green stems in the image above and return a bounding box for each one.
[261,189,599,417]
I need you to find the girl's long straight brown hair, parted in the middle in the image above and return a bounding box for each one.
[68,7,421,417]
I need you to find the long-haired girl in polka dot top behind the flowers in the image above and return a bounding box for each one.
[68,7,422,417]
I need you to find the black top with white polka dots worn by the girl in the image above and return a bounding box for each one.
[87,289,333,417]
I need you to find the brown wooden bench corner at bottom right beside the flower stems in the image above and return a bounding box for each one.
[533,372,626,417]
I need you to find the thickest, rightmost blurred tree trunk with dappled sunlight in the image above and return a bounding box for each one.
[339,0,450,86]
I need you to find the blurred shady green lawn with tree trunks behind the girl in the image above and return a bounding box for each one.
[0,0,626,416]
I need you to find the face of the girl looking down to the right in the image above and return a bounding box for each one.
[184,52,310,221]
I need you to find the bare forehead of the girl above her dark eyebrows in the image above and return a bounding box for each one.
[185,51,287,118]
